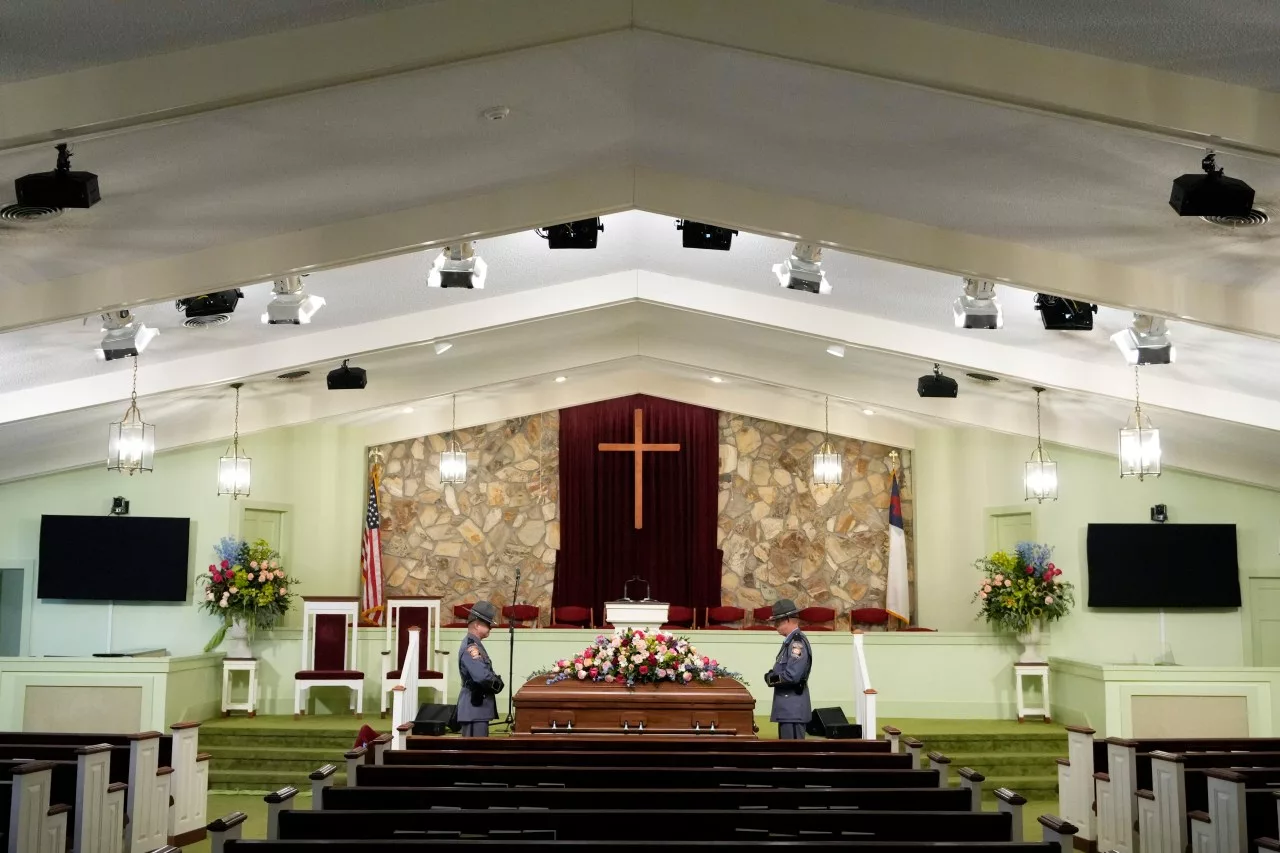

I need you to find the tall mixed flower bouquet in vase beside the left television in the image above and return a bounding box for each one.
[201,537,298,652]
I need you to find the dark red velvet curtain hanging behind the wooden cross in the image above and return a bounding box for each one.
[553,394,722,622]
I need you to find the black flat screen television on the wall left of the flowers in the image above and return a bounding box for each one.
[36,515,191,601]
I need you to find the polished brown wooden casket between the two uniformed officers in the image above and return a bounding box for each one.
[515,676,755,738]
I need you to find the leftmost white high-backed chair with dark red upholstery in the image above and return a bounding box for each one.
[293,596,365,720]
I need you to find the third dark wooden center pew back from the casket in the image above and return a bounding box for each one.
[348,765,940,790]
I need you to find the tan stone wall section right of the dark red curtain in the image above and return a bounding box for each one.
[719,412,915,622]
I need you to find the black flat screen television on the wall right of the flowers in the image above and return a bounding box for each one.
[1087,524,1240,608]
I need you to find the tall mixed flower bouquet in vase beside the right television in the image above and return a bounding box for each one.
[973,542,1075,633]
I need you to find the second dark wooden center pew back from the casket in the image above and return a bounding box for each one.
[383,748,911,770]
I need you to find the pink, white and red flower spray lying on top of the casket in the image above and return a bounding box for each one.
[534,628,745,686]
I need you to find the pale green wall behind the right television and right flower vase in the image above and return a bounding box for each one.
[915,429,1280,666]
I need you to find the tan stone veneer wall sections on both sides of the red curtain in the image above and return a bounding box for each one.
[379,411,914,624]
